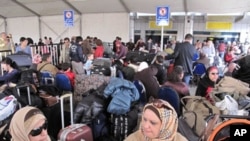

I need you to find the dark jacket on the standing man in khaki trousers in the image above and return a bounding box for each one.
[69,44,87,64]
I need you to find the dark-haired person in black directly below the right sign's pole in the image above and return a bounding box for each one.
[152,55,167,85]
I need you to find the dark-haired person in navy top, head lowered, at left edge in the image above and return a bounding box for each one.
[0,57,20,85]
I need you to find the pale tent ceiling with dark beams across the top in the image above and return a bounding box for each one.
[0,0,250,18]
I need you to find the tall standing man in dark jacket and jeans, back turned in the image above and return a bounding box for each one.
[166,34,196,85]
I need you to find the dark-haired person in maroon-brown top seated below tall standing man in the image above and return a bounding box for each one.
[163,66,190,98]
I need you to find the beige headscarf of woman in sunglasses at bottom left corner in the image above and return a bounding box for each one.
[9,106,50,141]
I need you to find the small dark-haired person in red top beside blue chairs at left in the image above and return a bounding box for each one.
[61,63,75,88]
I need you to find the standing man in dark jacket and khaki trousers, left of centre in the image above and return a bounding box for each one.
[69,36,87,74]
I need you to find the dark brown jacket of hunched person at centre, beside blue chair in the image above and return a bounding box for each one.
[134,67,160,100]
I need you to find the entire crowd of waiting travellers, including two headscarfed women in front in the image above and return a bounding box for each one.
[0,31,250,141]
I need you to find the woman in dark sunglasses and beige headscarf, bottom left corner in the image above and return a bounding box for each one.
[9,106,51,141]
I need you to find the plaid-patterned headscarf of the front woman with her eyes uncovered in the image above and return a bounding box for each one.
[141,99,178,141]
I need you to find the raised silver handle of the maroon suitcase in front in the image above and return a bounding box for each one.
[60,93,74,128]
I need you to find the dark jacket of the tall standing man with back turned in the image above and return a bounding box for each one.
[166,42,197,75]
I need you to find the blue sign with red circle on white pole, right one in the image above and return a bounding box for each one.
[156,6,170,26]
